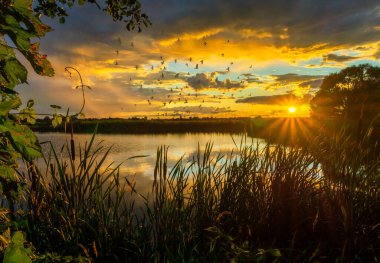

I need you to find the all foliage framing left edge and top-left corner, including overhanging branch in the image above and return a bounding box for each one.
[0,0,150,199]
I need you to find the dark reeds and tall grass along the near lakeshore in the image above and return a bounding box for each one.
[18,131,380,262]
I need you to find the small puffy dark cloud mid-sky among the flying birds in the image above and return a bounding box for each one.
[187,72,246,89]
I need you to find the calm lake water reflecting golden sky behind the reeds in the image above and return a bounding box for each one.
[37,133,265,194]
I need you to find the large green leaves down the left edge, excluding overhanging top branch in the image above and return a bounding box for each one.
[0,0,54,198]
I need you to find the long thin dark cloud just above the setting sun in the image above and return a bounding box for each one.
[236,94,312,105]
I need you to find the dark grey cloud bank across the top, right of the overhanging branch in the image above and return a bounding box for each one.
[143,0,380,47]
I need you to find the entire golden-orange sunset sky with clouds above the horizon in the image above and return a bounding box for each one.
[18,0,380,118]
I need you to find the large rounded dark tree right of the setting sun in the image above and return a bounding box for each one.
[310,64,380,134]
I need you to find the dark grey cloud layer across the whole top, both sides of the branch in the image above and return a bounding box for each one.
[43,0,380,56]
